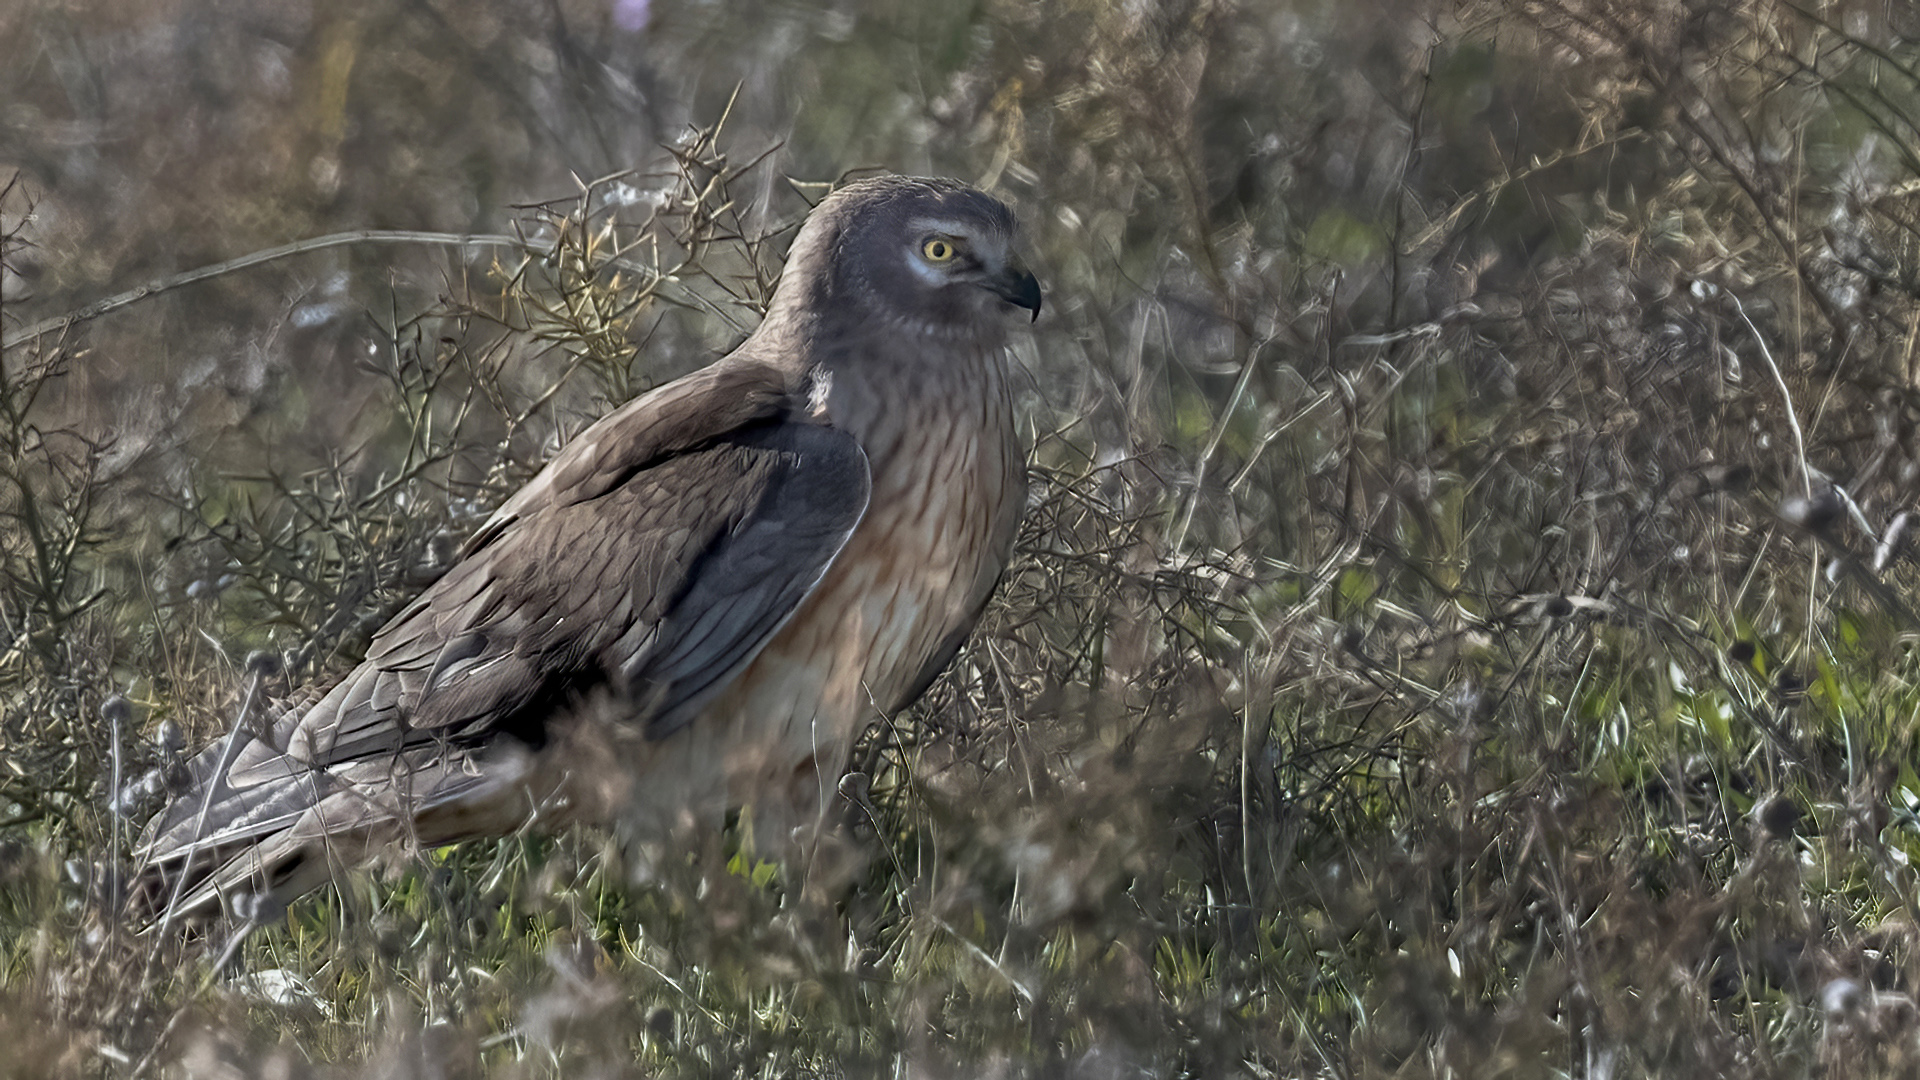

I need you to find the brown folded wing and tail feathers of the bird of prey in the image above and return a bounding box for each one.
[140,363,870,913]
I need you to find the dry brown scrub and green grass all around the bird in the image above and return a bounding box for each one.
[0,0,1920,1080]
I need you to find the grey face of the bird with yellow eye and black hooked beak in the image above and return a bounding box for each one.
[817,177,1041,338]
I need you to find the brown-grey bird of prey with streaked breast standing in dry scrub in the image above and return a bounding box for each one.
[132,177,1041,920]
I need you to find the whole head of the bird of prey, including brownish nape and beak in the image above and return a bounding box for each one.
[774,177,1041,342]
